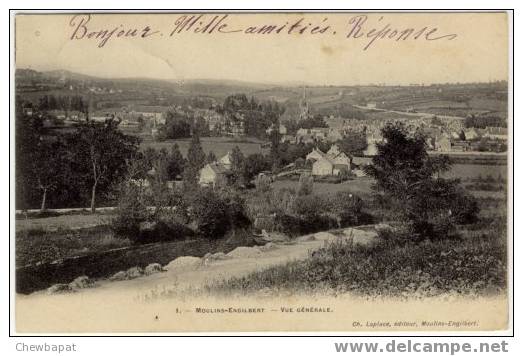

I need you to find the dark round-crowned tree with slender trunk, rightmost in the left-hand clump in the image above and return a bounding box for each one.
[68,119,139,213]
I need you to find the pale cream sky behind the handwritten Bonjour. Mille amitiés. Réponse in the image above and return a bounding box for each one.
[15,13,509,85]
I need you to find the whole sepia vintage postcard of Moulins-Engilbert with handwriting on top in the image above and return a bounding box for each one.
[10,12,512,334]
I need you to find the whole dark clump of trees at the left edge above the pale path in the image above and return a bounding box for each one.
[15,101,138,209]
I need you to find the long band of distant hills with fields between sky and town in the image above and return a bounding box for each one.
[15,69,508,118]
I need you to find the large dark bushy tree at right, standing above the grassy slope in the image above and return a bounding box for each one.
[365,123,478,238]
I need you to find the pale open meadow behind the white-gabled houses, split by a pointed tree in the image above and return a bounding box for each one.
[141,137,266,158]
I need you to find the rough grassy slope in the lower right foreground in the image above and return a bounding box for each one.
[206,231,507,298]
